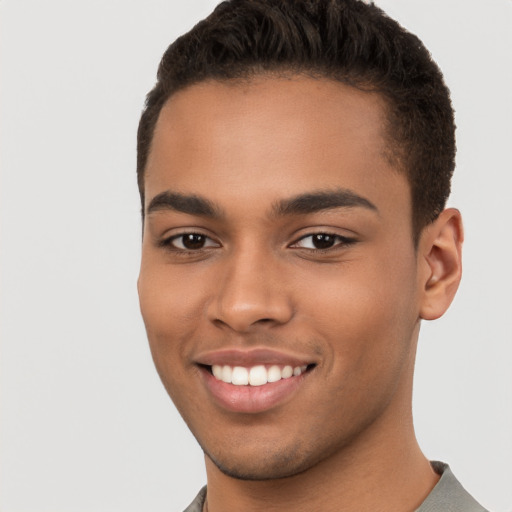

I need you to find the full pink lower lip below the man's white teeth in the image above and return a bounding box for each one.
[201,368,309,414]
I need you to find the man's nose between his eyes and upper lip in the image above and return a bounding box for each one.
[208,247,293,332]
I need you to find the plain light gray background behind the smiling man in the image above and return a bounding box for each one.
[0,0,512,512]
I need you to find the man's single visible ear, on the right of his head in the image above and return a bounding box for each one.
[418,208,464,320]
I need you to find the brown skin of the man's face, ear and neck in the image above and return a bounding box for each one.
[138,77,462,512]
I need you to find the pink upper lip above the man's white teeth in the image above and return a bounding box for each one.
[195,348,315,367]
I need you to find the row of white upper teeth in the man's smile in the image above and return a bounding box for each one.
[212,364,307,386]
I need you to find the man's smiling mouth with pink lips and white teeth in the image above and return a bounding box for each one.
[196,351,317,414]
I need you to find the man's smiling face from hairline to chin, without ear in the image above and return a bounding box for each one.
[138,77,419,479]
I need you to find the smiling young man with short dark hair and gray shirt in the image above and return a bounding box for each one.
[138,0,484,512]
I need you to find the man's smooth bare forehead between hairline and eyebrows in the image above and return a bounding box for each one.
[146,77,403,214]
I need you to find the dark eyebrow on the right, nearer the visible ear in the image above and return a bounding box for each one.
[272,189,379,217]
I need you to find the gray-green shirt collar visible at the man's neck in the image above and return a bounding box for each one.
[183,461,488,512]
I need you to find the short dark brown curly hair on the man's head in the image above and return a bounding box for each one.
[137,0,455,240]
